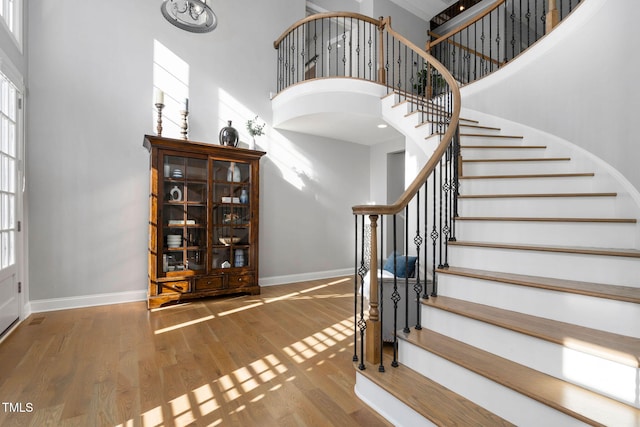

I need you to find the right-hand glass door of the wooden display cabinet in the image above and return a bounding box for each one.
[211,160,253,269]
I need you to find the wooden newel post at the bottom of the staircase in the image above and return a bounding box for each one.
[365,215,382,364]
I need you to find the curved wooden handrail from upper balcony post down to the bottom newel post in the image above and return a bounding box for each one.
[352,18,460,215]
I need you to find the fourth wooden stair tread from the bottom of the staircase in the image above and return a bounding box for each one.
[436,266,640,304]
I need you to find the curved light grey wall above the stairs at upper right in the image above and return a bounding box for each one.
[461,0,640,194]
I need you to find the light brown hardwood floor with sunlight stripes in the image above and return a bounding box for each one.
[0,278,389,427]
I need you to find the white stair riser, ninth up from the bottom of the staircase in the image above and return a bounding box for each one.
[462,160,577,176]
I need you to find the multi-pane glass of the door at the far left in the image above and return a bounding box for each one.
[0,74,18,270]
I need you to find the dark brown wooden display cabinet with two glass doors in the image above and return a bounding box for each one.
[144,135,266,308]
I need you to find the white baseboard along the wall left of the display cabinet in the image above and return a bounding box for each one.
[26,289,147,313]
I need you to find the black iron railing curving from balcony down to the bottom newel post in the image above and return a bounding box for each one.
[274,13,460,370]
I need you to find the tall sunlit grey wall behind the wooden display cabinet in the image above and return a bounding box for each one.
[27,0,369,300]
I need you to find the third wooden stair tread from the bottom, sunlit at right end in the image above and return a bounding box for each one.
[422,296,640,368]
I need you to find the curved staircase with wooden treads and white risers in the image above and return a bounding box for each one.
[356,96,640,427]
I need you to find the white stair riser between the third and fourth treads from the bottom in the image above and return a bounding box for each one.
[438,273,640,338]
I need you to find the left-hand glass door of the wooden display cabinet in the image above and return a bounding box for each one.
[159,155,209,276]
